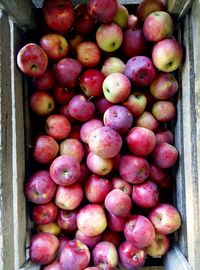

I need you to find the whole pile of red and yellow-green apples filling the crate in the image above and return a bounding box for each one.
[17,0,183,270]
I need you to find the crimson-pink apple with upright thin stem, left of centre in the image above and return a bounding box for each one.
[69,95,95,122]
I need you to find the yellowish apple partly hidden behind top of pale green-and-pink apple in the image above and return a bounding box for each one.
[101,56,125,77]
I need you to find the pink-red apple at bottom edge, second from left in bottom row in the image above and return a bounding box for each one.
[60,239,90,270]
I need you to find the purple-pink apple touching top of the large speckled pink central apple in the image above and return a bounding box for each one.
[103,105,133,134]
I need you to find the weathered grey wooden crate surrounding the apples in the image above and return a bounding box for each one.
[0,0,200,270]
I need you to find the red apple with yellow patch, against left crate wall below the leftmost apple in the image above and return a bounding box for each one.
[30,91,55,116]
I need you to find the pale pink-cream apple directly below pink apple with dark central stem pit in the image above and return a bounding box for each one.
[55,183,83,210]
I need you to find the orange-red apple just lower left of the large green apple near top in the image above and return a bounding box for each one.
[76,41,101,68]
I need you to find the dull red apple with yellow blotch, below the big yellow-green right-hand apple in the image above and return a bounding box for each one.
[150,72,178,100]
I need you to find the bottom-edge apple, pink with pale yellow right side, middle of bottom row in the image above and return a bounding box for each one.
[92,241,118,270]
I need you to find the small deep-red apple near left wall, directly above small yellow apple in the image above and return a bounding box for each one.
[32,202,58,224]
